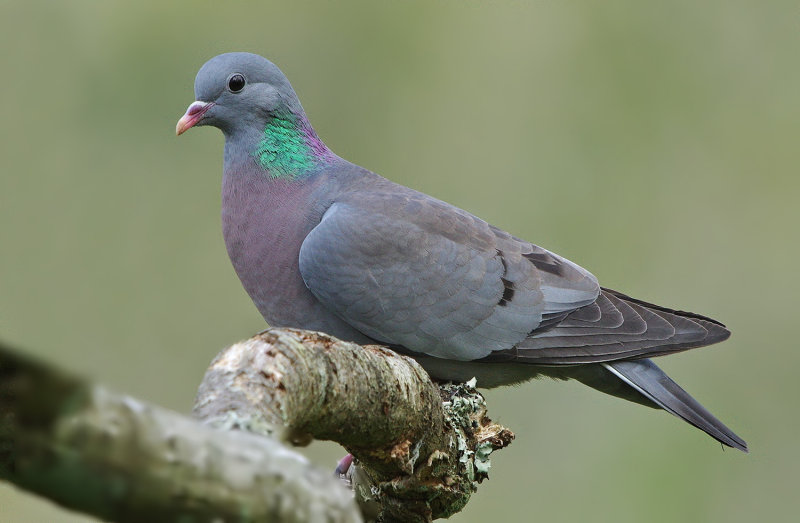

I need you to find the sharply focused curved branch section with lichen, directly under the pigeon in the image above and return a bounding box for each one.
[194,329,514,521]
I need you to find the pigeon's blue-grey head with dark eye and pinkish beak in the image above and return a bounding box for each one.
[175,53,303,136]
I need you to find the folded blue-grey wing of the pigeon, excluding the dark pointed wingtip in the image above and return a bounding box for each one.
[300,191,599,360]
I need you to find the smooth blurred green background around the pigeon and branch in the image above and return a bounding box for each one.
[0,0,800,522]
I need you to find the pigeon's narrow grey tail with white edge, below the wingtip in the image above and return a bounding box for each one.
[600,359,747,452]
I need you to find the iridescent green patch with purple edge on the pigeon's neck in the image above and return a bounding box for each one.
[250,111,336,180]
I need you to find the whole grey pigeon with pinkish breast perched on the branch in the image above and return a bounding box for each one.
[176,52,747,452]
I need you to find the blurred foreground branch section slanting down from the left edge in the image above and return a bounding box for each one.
[0,340,361,523]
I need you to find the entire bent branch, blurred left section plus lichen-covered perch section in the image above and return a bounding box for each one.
[0,329,513,523]
